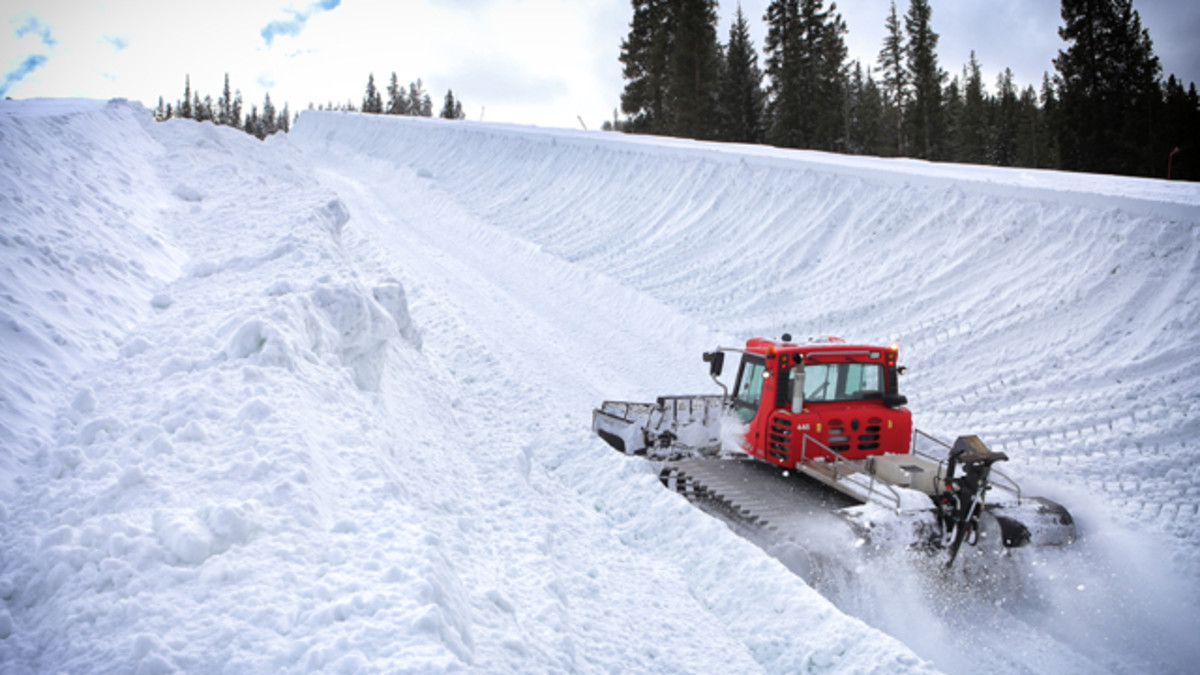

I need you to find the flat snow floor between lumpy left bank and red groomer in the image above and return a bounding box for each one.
[302,139,917,671]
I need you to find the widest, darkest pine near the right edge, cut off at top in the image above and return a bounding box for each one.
[1055,0,1165,174]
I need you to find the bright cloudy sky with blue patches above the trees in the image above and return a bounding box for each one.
[0,0,1200,129]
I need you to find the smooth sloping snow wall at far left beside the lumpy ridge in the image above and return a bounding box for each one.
[0,101,181,496]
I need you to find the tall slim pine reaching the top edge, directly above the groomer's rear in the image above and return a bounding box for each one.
[904,0,946,160]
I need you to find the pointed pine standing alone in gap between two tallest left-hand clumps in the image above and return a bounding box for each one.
[721,5,767,143]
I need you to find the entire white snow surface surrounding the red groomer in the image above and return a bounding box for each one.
[0,101,1200,673]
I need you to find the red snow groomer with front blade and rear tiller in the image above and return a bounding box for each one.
[593,334,1075,565]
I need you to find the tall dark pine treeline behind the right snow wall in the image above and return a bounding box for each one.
[606,0,1200,180]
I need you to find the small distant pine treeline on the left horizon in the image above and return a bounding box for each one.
[155,73,466,139]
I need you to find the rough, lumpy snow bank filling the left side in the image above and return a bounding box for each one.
[0,102,469,673]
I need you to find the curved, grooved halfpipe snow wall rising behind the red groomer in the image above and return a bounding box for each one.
[292,113,1200,569]
